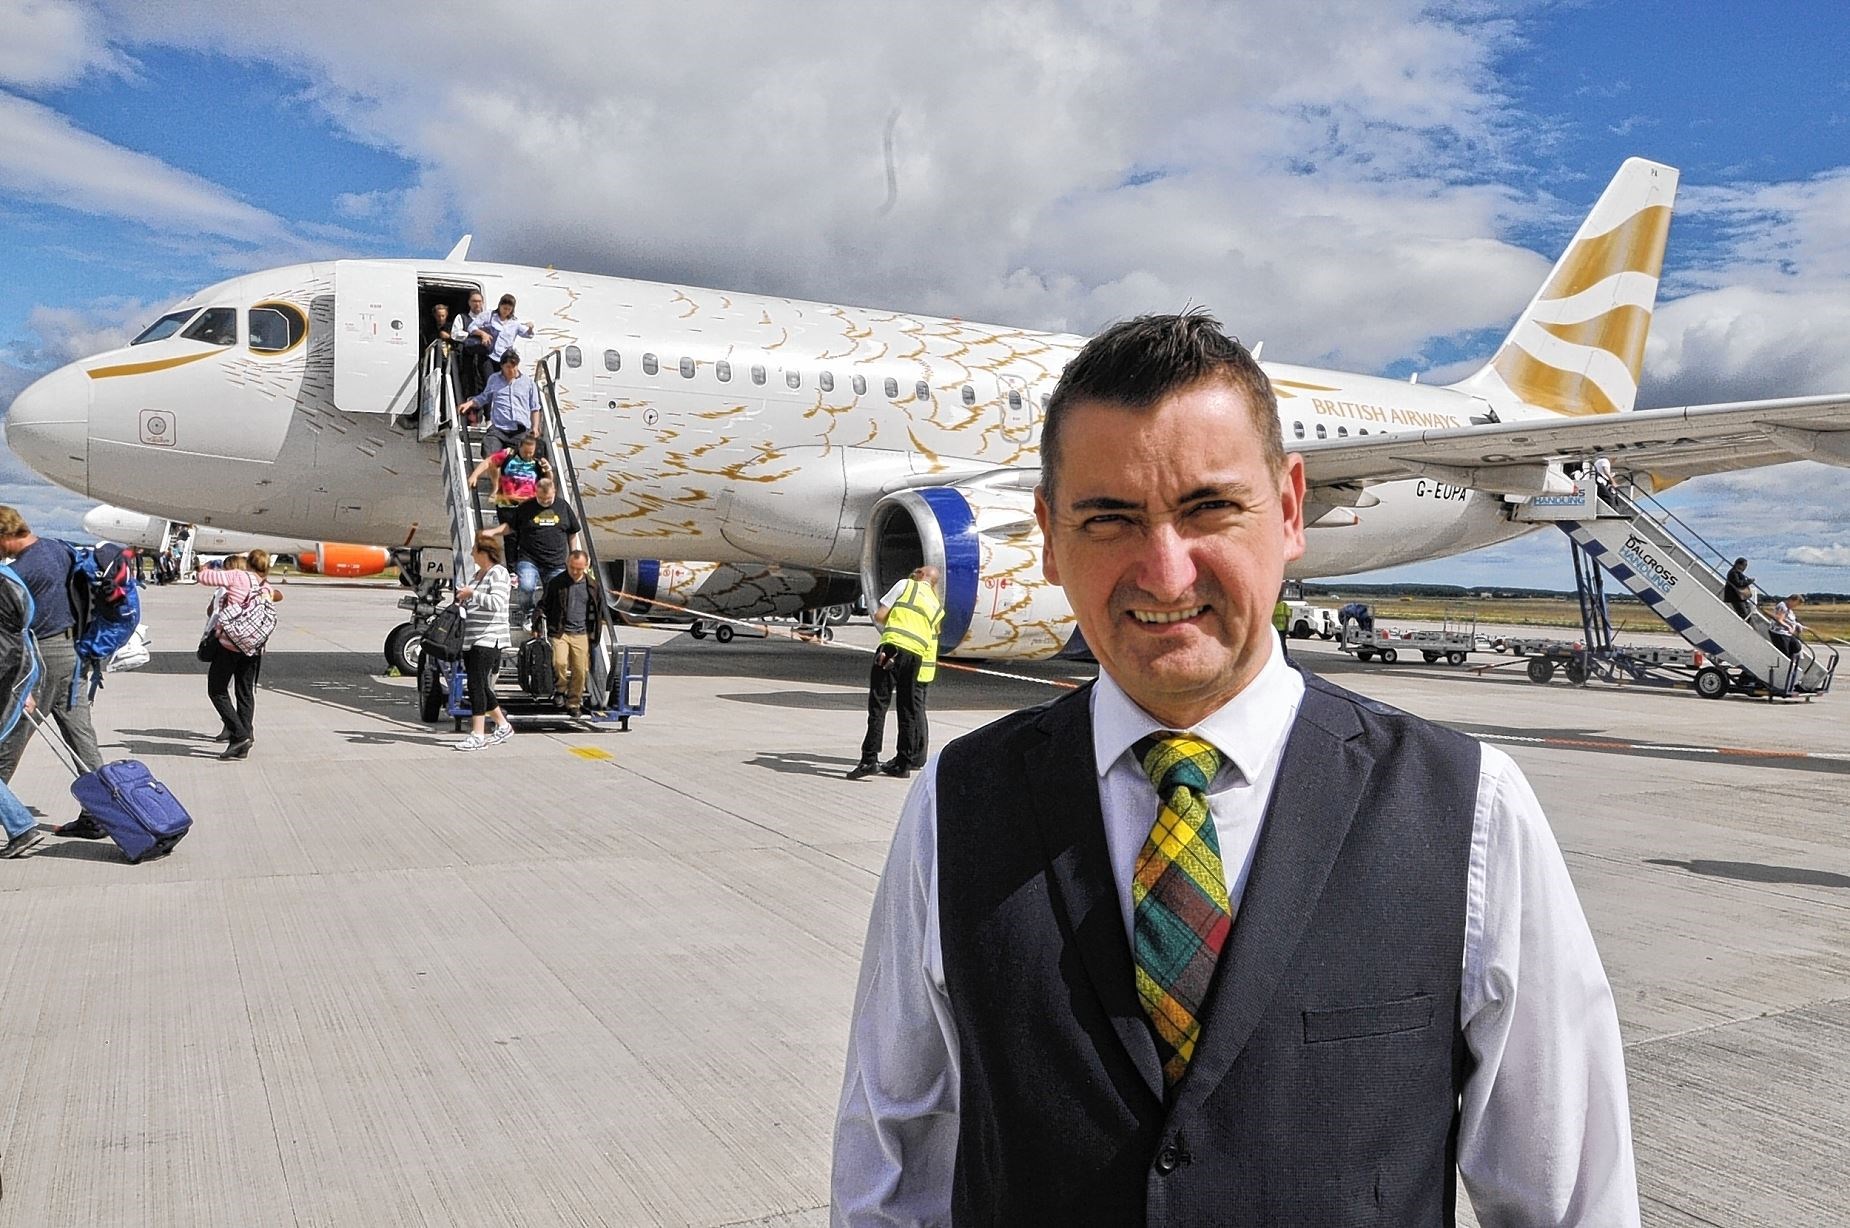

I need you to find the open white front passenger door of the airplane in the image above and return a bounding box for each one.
[335,261,418,414]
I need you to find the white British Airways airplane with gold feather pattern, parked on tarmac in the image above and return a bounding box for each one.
[6,159,1850,658]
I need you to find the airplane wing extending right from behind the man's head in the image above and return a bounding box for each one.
[1291,396,1850,491]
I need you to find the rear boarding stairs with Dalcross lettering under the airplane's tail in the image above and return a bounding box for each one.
[1517,477,1837,699]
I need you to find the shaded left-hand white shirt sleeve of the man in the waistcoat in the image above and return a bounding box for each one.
[831,758,958,1228]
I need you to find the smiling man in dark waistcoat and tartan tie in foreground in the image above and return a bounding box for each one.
[833,314,1639,1228]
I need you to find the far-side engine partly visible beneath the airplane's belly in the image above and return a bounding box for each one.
[609,559,860,618]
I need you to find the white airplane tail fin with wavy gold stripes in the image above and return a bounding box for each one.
[1452,157,1678,414]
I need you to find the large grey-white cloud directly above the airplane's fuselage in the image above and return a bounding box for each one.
[86,0,1545,368]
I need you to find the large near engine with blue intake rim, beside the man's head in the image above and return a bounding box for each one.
[860,473,1077,660]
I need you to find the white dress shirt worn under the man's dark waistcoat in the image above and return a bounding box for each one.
[831,645,1639,1228]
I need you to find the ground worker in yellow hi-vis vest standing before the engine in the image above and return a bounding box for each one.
[847,566,944,780]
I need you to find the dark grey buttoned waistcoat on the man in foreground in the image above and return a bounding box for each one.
[938,677,1480,1228]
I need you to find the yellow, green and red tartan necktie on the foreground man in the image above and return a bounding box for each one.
[1130,732,1234,1091]
